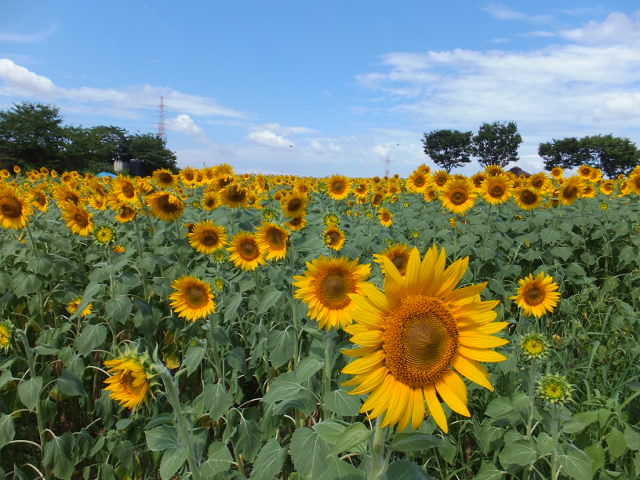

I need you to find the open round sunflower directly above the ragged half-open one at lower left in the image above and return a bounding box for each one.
[169,275,216,322]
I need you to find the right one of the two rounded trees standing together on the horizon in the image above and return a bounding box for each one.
[473,122,522,167]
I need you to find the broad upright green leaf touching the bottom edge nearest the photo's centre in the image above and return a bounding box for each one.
[289,427,329,478]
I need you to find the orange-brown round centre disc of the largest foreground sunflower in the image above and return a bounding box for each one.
[382,295,458,388]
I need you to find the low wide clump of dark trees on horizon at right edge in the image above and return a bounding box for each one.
[538,135,640,178]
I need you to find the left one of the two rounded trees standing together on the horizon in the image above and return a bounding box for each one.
[422,130,473,173]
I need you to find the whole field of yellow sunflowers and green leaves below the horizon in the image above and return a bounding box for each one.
[0,164,640,480]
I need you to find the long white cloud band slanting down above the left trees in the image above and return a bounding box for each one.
[0,58,247,118]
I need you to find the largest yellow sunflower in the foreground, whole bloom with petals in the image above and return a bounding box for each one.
[343,245,508,432]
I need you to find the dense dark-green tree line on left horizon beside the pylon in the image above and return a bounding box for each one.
[0,102,177,175]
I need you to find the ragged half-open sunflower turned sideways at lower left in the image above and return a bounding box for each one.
[104,350,157,410]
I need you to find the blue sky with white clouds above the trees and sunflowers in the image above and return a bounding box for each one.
[0,0,640,176]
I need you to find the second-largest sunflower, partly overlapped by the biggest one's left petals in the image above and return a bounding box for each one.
[293,256,371,328]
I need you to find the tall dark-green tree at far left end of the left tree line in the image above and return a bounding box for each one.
[0,102,64,169]
